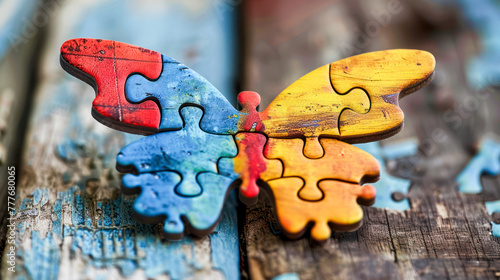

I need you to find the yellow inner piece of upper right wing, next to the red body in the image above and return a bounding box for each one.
[259,65,371,142]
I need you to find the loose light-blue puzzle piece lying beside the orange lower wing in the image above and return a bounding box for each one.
[355,141,418,211]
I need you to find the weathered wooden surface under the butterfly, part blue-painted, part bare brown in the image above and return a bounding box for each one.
[1,0,500,279]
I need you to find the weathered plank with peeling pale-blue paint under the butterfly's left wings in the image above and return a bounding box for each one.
[2,1,240,279]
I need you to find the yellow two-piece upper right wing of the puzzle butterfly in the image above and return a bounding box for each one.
[260,50,435,142]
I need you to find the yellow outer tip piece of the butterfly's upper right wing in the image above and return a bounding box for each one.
[330,50,436,143]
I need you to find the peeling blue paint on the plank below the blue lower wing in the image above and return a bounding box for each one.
[15,186,239,280]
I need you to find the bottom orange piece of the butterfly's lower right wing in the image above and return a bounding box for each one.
[268,177,375,241]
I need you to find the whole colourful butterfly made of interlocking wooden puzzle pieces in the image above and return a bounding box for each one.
[61,39,435,241]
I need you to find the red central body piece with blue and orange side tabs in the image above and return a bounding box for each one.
[218,132,283,204]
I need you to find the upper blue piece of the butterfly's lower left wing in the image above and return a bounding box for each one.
[117,107,237,196]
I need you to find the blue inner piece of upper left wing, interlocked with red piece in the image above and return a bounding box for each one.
[125,55,240,134]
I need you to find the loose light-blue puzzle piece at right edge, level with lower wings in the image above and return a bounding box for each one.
[457,139,500,193]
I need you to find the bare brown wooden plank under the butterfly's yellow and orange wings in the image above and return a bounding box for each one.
[243,1,500,279]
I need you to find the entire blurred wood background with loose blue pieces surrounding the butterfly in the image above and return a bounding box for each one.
[0,0,500,279]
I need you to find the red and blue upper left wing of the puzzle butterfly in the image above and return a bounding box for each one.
[61,39,240,134]
